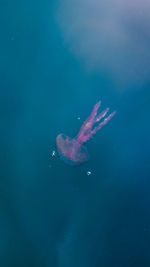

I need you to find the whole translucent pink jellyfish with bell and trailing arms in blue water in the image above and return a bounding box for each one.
[56,101,116,165]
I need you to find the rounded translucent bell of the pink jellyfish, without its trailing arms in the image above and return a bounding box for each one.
[56,134,89,165]
